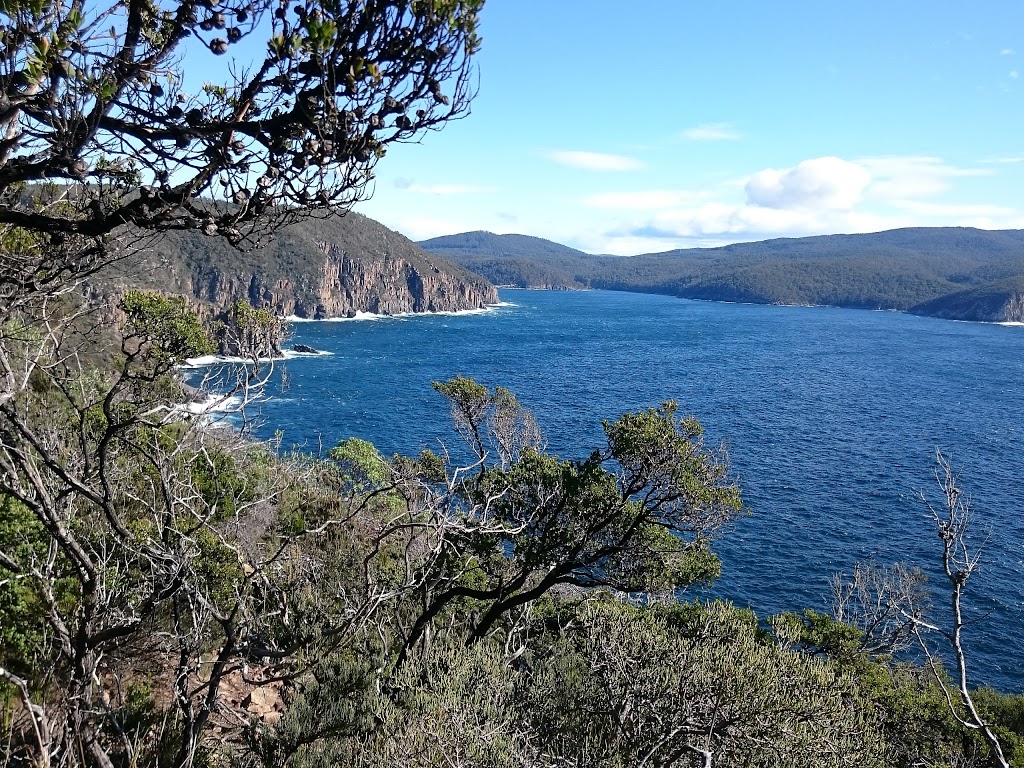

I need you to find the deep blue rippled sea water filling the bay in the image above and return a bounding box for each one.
[192,291,1024,692]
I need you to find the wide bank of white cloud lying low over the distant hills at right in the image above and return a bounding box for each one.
[586,156,1024,253]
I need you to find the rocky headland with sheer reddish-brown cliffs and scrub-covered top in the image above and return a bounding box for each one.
[103,214,498,318]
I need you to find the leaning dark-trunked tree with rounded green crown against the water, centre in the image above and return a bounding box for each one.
[387,377,742,652]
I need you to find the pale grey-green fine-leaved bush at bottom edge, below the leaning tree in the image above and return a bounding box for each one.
[522,600,891,768]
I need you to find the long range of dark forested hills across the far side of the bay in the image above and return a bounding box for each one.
[421,227,1024,322]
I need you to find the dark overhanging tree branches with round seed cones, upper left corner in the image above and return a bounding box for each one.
[0,0,483,312]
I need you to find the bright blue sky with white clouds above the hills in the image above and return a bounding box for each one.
[218,0,1024,255]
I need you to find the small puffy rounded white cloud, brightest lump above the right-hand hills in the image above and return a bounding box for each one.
[744,158,871,210]
